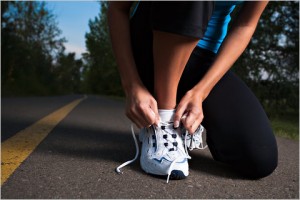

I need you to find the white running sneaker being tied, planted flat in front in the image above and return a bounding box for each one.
[140,122,189,182]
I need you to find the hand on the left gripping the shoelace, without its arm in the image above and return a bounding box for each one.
[126,86,160,128]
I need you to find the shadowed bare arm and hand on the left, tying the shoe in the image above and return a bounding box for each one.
[108,1,159,128]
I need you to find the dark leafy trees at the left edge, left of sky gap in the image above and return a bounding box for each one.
[1,1,82,95]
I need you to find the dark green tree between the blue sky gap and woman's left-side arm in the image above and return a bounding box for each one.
[84,1,122,95]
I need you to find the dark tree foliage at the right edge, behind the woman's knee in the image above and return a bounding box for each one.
[234,1,299,115]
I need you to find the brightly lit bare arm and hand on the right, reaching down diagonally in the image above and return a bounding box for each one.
[175,1,268,133]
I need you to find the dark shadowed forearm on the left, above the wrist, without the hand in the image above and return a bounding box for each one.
[108,2,142,94]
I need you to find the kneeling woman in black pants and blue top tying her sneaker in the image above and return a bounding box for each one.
[108,1,277,182]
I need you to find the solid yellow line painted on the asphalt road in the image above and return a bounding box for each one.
[1,97,86,185]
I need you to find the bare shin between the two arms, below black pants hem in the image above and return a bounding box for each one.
[153,31,198,109]
